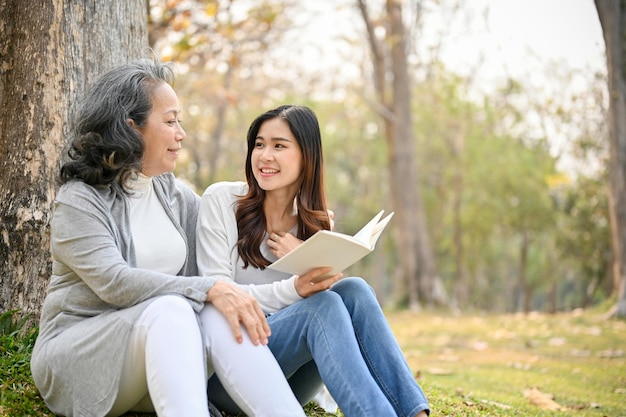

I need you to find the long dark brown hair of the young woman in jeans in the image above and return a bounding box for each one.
[236,105,330,269]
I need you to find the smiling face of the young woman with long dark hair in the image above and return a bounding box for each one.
[250,117,303,195]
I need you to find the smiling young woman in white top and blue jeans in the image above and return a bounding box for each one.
[197,106,430,417]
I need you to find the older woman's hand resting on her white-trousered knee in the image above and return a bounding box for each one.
[207,281,271,345]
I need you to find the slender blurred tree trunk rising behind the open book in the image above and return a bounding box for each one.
[357,0,447,308]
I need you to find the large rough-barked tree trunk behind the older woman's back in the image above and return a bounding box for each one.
[0,0,148,318]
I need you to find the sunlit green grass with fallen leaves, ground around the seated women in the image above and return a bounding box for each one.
[0,311,626,417]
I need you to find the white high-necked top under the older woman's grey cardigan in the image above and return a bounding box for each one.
[127,174,187,275]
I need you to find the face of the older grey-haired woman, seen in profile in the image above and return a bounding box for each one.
[138,83,186,177]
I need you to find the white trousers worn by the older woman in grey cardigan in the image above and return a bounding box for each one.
[108,296,305,417]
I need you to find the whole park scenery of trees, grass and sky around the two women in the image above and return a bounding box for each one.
[0,0,626,417]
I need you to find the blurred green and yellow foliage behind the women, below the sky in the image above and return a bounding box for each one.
[150,0,613,311]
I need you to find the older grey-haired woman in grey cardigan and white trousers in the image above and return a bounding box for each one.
[31,60,304,417]
